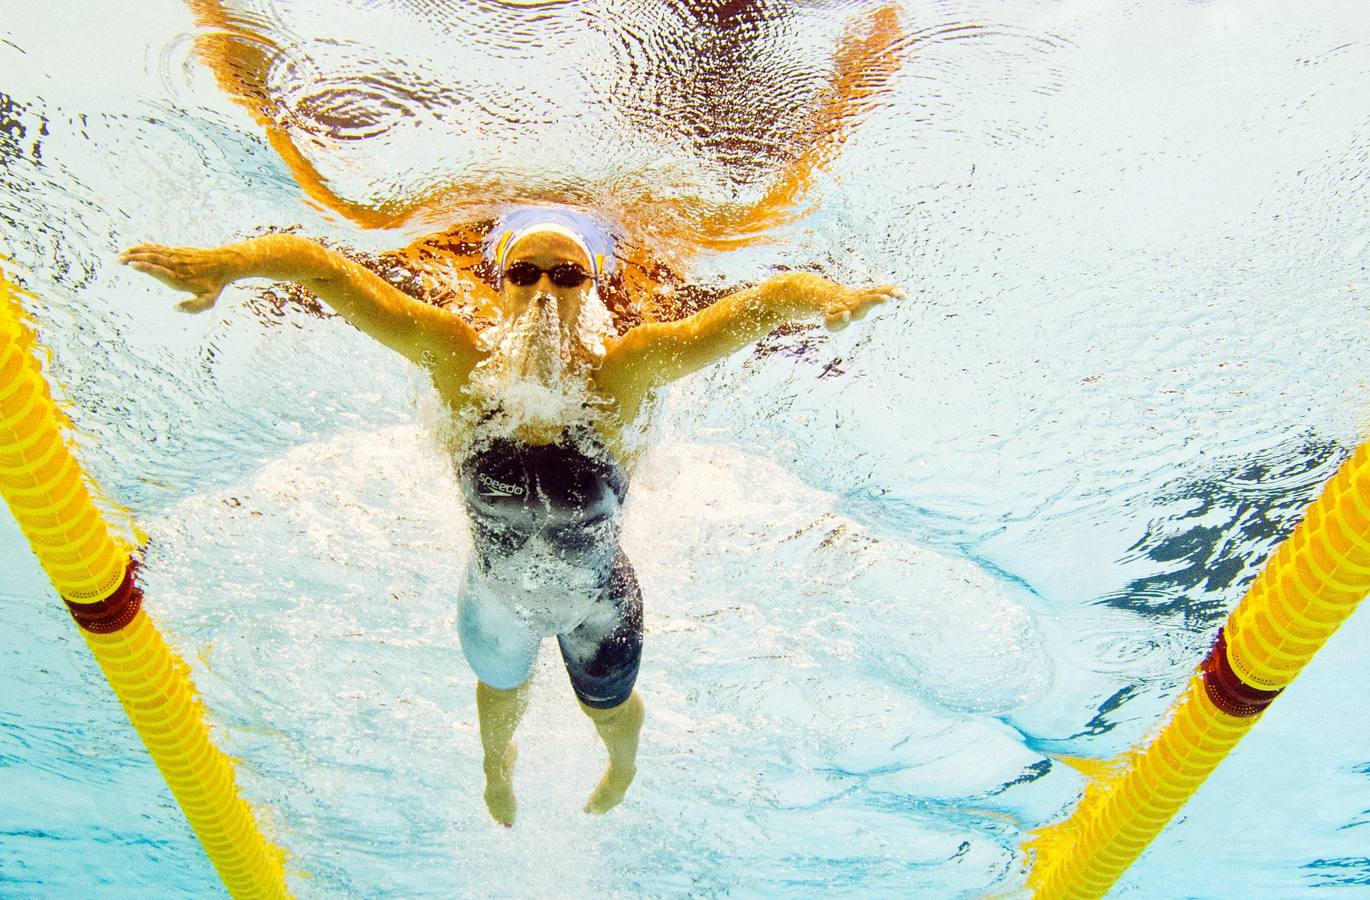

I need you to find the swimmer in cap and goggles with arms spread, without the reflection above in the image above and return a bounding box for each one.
[119,208,901,826]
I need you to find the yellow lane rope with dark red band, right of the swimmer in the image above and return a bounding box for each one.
[1025,444,1370,899]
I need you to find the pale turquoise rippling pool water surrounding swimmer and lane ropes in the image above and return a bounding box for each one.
[0,1,1370,897]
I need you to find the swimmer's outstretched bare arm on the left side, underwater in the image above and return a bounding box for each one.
[119,234,478,371]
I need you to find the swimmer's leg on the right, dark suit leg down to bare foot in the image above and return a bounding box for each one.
[558,551,644,812]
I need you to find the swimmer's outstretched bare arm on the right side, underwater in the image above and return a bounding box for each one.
[600,273,903,390]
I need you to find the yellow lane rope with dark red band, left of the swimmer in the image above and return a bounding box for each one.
[0,271,289,897]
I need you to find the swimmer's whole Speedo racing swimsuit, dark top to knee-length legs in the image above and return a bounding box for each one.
[459,429,643,708]
